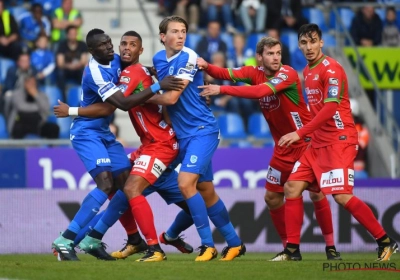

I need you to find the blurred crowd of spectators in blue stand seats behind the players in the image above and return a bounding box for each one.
[0,0,400,177]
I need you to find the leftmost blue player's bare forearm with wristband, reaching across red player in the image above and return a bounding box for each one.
[106,76,185,111]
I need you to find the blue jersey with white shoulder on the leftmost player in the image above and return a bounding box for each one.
[71,54,121,135]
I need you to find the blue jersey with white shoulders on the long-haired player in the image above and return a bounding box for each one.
[153,47,219,139]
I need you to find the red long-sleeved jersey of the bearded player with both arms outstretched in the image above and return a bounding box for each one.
[207,65,311,148]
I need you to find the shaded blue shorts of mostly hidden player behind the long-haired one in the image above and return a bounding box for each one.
[143,170,185,205]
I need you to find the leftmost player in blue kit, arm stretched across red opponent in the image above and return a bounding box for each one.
[52,29,183,260]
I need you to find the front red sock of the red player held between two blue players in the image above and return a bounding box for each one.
[129,195,158,245]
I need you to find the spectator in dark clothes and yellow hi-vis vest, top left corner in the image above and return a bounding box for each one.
[0,0,21,60]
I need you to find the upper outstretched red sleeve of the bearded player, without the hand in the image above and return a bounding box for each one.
[206,64,254,84]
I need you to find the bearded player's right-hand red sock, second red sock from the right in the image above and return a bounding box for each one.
[314,197,335,246]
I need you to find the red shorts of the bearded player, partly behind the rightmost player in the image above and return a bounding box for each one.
[265,145,308,193]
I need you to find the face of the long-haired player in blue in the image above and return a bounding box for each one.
[160,21,186,53]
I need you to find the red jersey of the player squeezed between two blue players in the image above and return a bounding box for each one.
[119,63,175,145]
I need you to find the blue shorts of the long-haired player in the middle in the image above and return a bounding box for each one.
[178,132,219,182]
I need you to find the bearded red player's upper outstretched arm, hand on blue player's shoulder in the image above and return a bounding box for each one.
[196,57,254,84]
